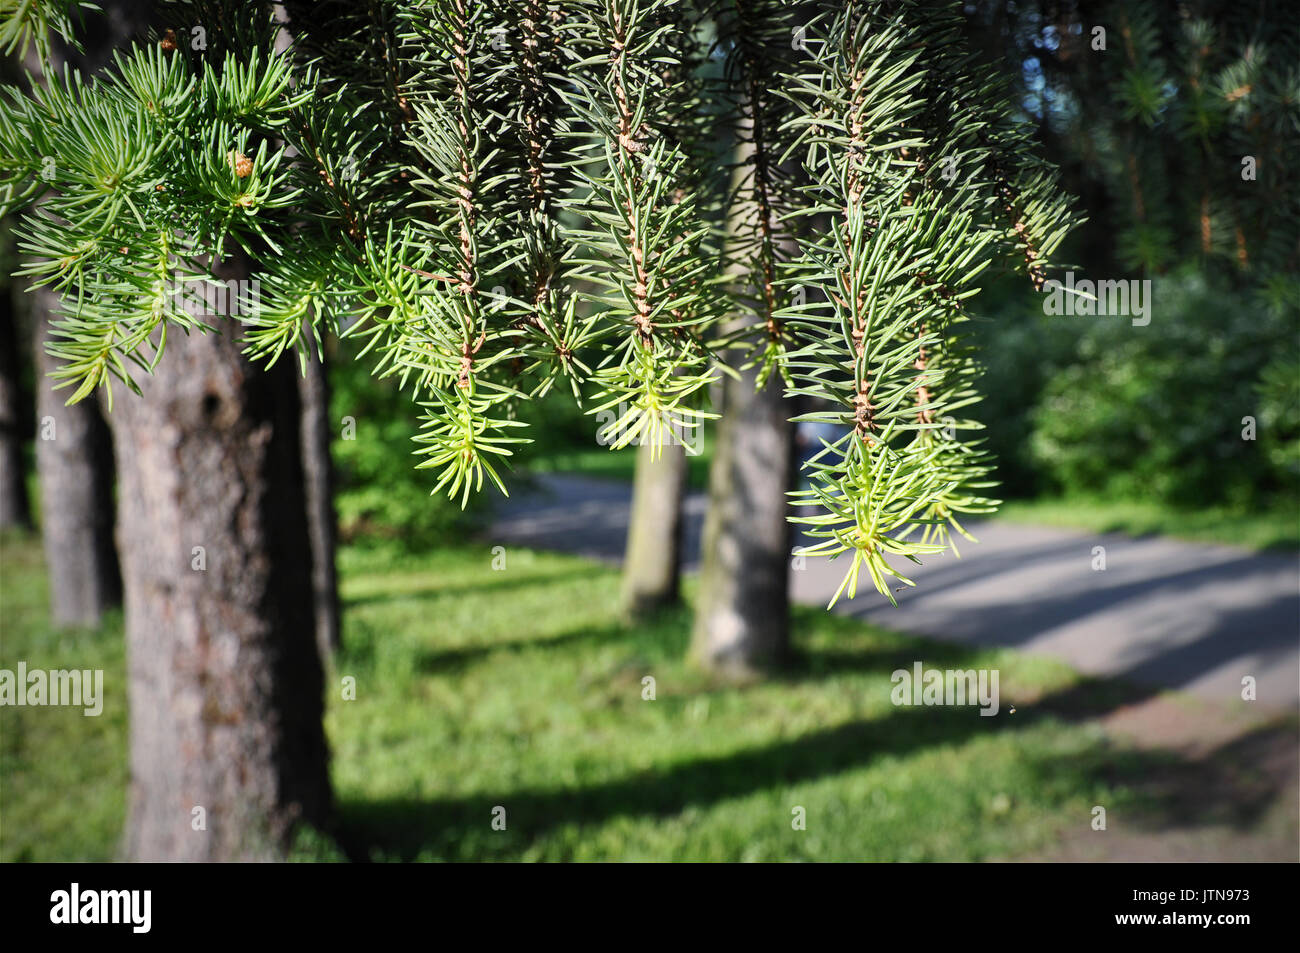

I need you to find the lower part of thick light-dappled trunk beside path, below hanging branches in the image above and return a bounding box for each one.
[692,361,794,677]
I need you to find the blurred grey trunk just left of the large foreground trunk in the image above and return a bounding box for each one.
[29,289,122,625]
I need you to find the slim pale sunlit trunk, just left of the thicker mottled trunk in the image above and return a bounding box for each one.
[621,443,686,619]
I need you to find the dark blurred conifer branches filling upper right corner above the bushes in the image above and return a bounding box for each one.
[978,0,1300,293]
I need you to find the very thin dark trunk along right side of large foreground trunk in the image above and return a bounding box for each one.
[298,351,339,662]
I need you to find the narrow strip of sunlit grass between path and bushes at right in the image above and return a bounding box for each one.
[996,498,1300,550]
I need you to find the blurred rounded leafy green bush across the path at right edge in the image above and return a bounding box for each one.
[1030,273,1300,507]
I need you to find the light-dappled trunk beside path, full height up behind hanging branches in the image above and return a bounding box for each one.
[692,0,807,675]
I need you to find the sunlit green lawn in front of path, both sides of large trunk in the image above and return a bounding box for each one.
[0,527,1180,861]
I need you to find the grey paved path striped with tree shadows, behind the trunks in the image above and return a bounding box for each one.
[490,475,1300,710]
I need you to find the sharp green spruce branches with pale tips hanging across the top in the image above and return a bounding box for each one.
[0,0,1071,608]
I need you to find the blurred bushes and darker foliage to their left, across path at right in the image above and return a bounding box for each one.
[978,267,1300,508]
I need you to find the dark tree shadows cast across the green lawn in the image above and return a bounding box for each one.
[341,628,1295,861]
